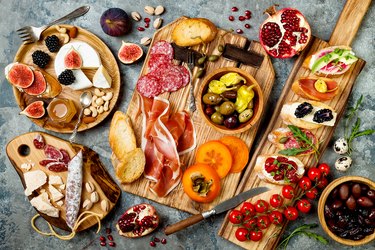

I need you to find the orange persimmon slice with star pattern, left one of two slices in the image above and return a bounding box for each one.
[195,141,233,179]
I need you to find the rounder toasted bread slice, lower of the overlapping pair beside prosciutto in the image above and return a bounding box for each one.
[116,148,146,183]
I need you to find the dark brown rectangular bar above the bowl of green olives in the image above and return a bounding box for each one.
[223,43,264,68]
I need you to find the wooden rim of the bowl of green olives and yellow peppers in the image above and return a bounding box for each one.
[197,67,264,134]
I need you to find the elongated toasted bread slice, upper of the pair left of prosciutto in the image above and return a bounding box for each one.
[109,111,137,161]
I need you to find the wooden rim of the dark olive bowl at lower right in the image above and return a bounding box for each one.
[318,176,375,246]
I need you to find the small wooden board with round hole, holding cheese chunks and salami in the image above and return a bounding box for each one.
[6,132,121,232]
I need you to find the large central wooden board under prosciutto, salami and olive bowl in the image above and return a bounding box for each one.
[117,17,275,214]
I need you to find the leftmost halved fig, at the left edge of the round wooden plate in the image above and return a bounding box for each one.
[5,63,34,88]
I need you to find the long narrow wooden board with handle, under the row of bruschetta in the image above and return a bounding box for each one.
[219,0,371,250]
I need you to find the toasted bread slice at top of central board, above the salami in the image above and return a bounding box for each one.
[172,18,217,46]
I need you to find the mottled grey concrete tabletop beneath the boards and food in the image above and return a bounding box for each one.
[0,0,375,249]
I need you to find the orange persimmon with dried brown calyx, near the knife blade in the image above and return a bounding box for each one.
[182,163,221,203]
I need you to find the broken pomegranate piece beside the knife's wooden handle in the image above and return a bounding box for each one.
[116,203,159,238]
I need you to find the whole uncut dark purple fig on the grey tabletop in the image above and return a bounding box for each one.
[100,8,131,36]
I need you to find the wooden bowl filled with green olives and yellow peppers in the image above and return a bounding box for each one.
[197,67,264,134]
